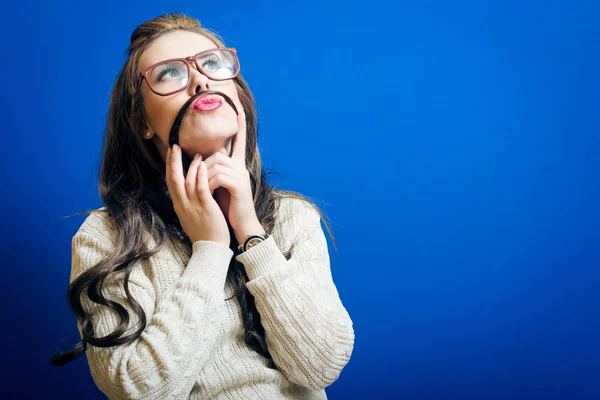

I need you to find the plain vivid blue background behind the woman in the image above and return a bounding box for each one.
[0,0,600,399]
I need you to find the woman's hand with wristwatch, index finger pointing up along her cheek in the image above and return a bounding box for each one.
[205,111,260,237]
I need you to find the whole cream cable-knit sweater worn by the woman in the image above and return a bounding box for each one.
[71,198,354,400]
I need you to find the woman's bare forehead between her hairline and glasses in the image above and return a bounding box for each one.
[139,31,217,71]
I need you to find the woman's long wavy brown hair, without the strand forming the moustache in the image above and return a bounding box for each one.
[51,14,337,365]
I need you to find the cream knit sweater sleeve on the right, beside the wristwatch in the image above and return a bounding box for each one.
[236,199,354,389]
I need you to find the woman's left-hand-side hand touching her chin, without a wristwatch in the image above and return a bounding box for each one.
[165,144,231,247]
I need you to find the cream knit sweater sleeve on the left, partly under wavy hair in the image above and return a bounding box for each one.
[71,216,233,399]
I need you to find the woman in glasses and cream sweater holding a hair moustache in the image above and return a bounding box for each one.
[52,10,354,399]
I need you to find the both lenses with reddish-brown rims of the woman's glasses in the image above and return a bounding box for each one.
[147,50,239,93]
